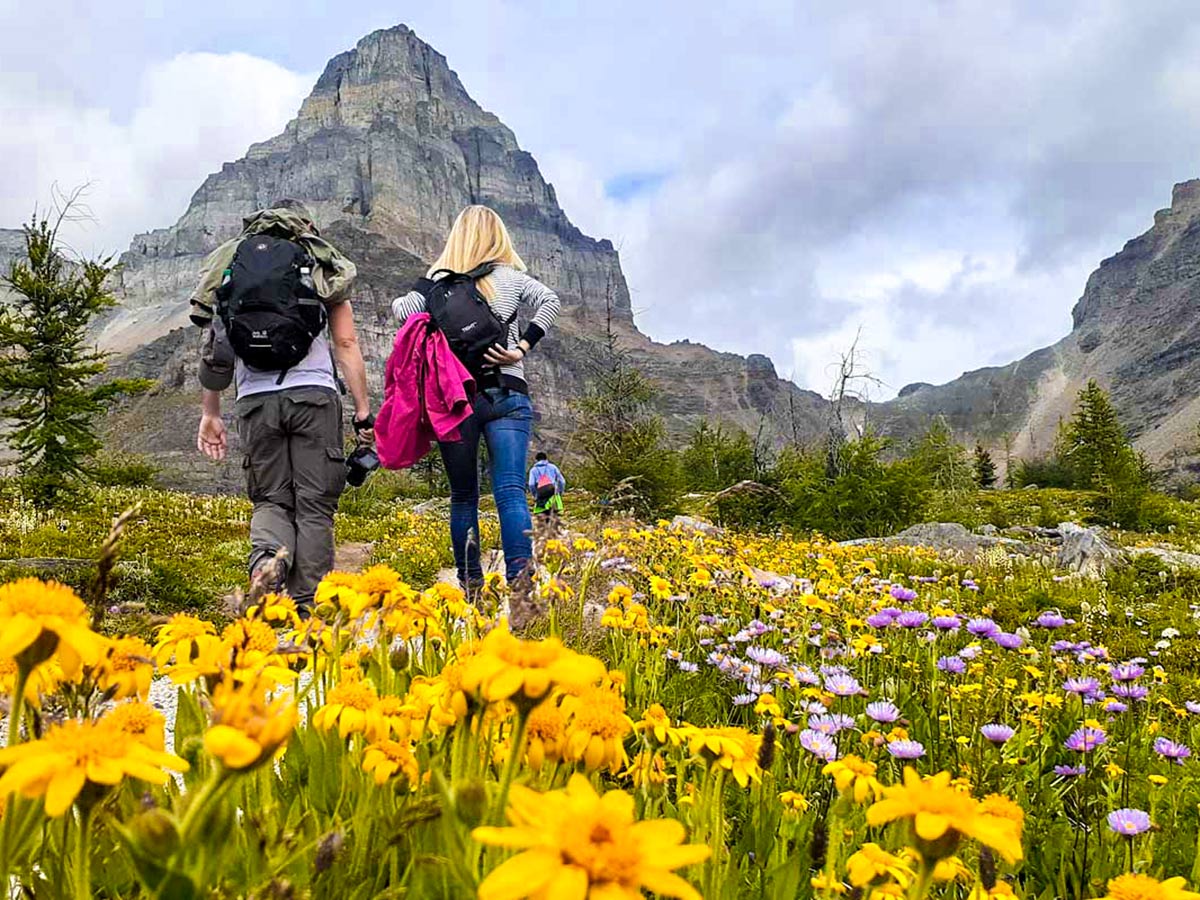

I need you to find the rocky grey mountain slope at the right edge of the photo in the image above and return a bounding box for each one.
[870,180,1200,464]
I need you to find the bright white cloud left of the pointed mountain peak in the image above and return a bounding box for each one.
[0,53,313,254]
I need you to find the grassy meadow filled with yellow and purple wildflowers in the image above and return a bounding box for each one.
[0,487,1200,900]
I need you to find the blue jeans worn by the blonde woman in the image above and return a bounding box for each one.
[438,388,533,587]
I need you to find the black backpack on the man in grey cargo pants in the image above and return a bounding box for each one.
[217,234,326,384]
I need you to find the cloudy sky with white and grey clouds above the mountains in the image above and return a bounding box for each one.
[0,0,1200,396]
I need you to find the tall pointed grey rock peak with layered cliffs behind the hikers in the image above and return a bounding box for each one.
[93,26,823,487]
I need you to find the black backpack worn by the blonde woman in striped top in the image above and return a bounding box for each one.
[415,263,517,378]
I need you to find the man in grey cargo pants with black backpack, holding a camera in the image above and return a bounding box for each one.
[191,200,373,616]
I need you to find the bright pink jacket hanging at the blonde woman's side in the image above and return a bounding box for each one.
[376,312,475,469]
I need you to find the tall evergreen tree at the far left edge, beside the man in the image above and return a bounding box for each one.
[0,212,144,506]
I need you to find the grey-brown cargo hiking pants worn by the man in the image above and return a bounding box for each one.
[235,388,346,606]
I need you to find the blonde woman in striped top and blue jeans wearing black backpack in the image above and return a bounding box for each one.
[391,206,560,590]
